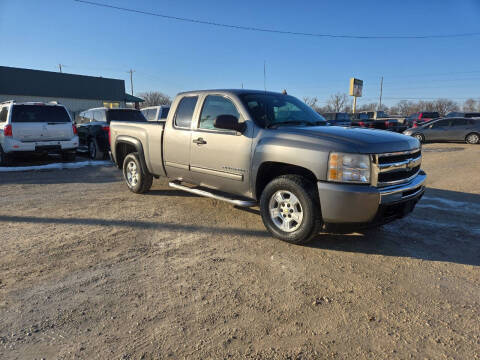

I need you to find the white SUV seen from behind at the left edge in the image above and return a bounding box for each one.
[0,100,78,165]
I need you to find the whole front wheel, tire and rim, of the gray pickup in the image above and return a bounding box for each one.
[260,175,322,244]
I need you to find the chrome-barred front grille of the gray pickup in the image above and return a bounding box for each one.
[372,149,422,187]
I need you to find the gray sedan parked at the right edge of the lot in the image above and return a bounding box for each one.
[404,118,480,144]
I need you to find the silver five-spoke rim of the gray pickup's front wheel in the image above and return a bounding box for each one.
[268,190,303,232]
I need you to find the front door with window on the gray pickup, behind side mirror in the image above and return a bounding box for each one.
[190,95,252,195]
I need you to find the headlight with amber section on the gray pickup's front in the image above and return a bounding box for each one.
[327,153,370,184]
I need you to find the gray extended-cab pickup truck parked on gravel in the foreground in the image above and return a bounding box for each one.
[110,89,426,244]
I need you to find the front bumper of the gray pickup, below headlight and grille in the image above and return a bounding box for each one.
[317,171,427,224]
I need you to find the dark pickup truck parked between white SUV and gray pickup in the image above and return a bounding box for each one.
[76,108,147,160]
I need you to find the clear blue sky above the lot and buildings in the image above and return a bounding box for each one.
[0,0,480,104]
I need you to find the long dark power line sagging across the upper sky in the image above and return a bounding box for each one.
[73,0,480,40]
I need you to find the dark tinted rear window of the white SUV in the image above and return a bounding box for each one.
[12,105,71,123]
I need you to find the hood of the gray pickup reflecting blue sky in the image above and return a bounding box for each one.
[277,126,420,154]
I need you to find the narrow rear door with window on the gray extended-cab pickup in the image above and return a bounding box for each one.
[162,95,198,181]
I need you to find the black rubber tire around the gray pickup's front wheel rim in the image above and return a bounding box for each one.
[260,175,322,244]
